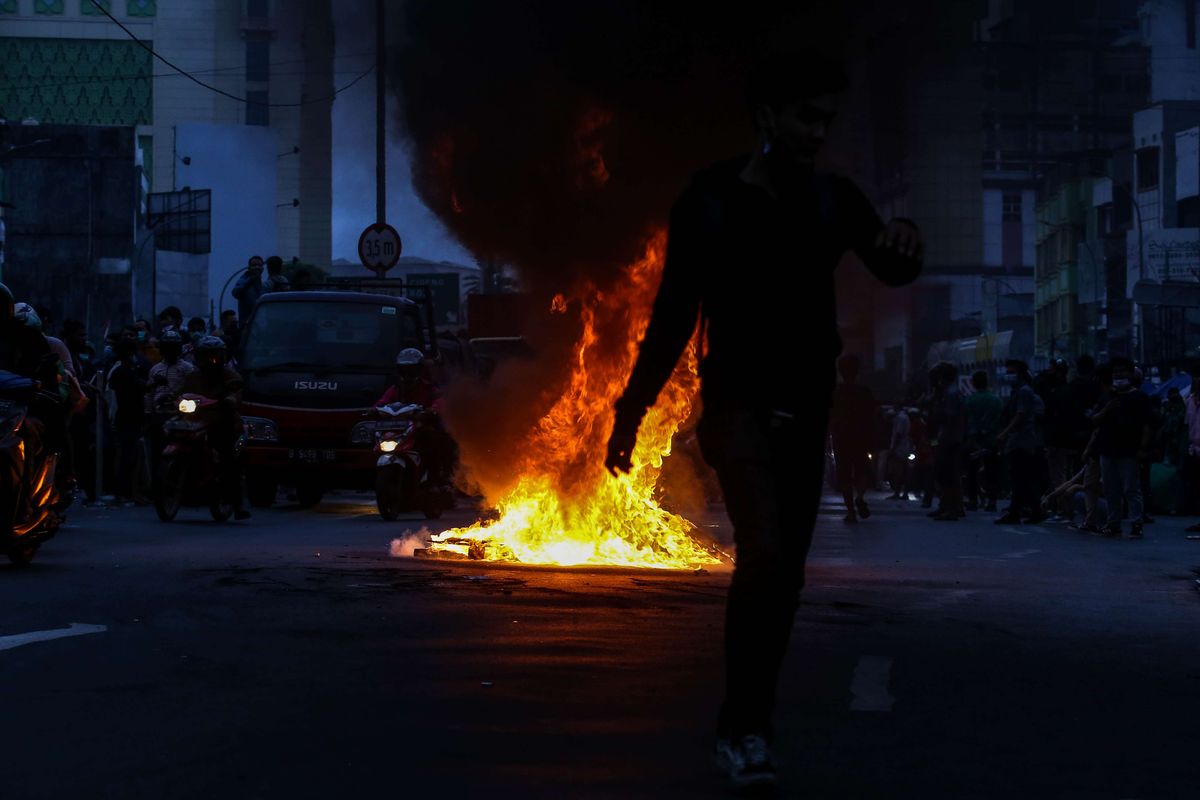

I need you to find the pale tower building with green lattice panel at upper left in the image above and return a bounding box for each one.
[0,0,333,315]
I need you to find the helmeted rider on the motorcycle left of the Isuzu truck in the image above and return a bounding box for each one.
[180,336,250,519]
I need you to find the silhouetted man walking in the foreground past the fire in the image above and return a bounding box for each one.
[605,54,922,787]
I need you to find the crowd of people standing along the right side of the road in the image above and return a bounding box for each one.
[830,355,1200,539]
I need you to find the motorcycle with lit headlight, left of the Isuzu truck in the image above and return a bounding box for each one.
[154,395,242,522]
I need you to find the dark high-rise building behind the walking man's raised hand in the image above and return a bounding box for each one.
[871,0,1150,388]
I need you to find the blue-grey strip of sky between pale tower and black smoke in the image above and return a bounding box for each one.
[332,2,474,264]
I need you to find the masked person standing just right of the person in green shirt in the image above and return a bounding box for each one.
[995,359,1046,525]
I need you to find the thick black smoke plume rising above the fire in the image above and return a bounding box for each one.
[389,0,859,290]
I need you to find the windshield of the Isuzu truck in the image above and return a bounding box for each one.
[239,301,421,371]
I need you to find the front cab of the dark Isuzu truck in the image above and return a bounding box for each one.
[236,291,436,507]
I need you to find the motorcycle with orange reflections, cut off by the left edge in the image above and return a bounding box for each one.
[0,371,67,566]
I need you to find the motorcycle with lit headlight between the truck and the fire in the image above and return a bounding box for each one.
[374,403,455,522]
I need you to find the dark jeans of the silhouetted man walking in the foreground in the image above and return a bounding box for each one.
[700,402,826,736]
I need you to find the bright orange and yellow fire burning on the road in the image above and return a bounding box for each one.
[430,233,720,569]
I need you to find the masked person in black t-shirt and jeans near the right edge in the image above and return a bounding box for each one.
[1092,357,1151,539]
